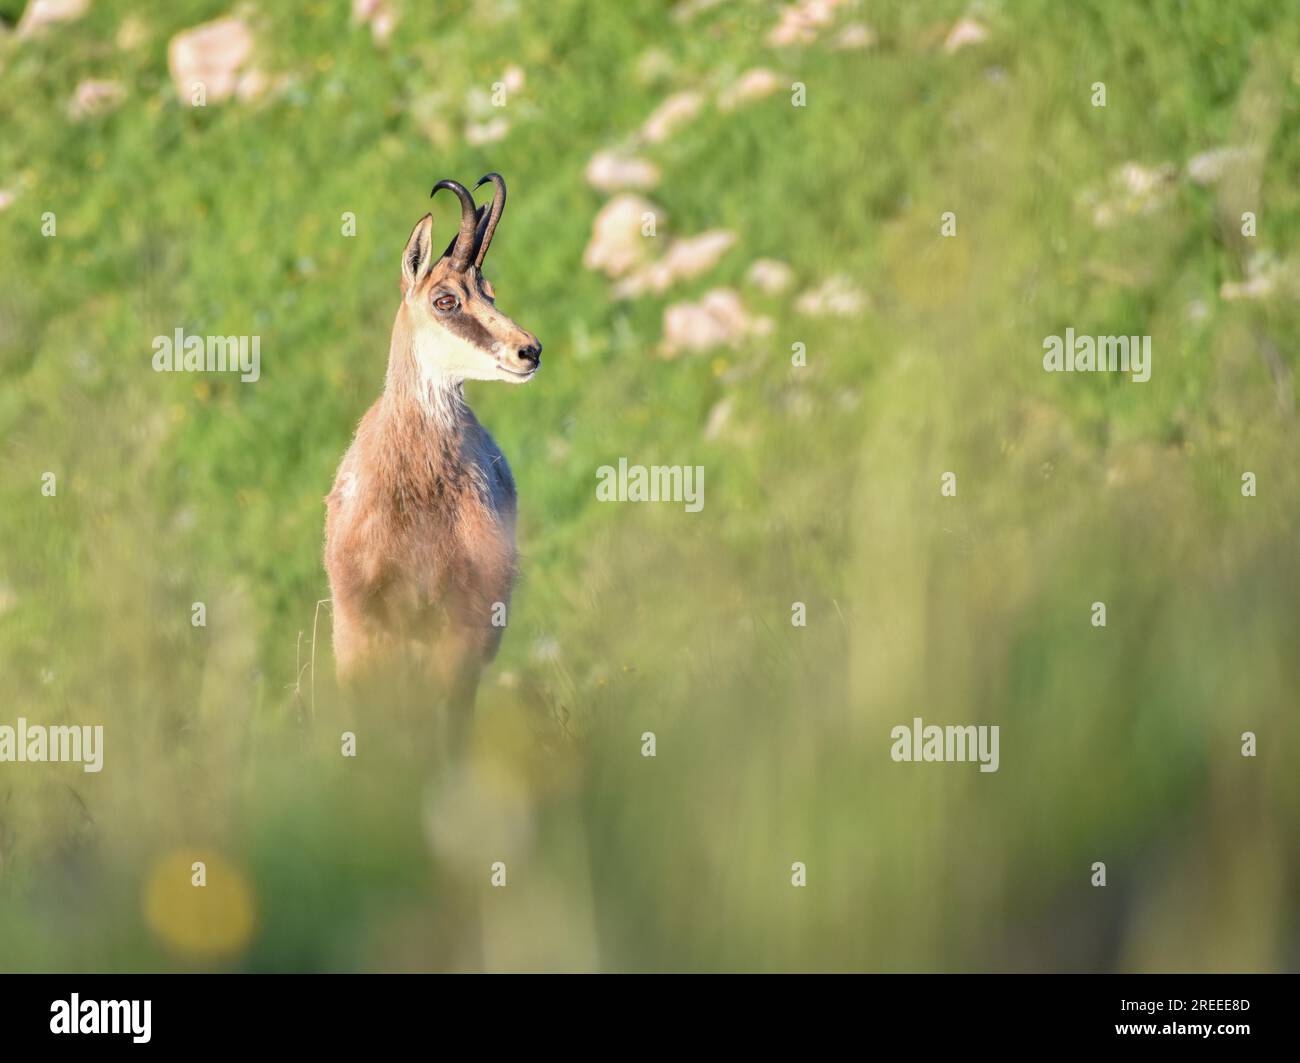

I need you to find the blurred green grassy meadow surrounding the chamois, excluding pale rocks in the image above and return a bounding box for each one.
[0,0,1300,971]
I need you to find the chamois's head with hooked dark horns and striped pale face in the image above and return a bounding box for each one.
[399,173,542,385]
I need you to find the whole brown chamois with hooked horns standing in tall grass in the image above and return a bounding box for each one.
[325,173,542,732]
